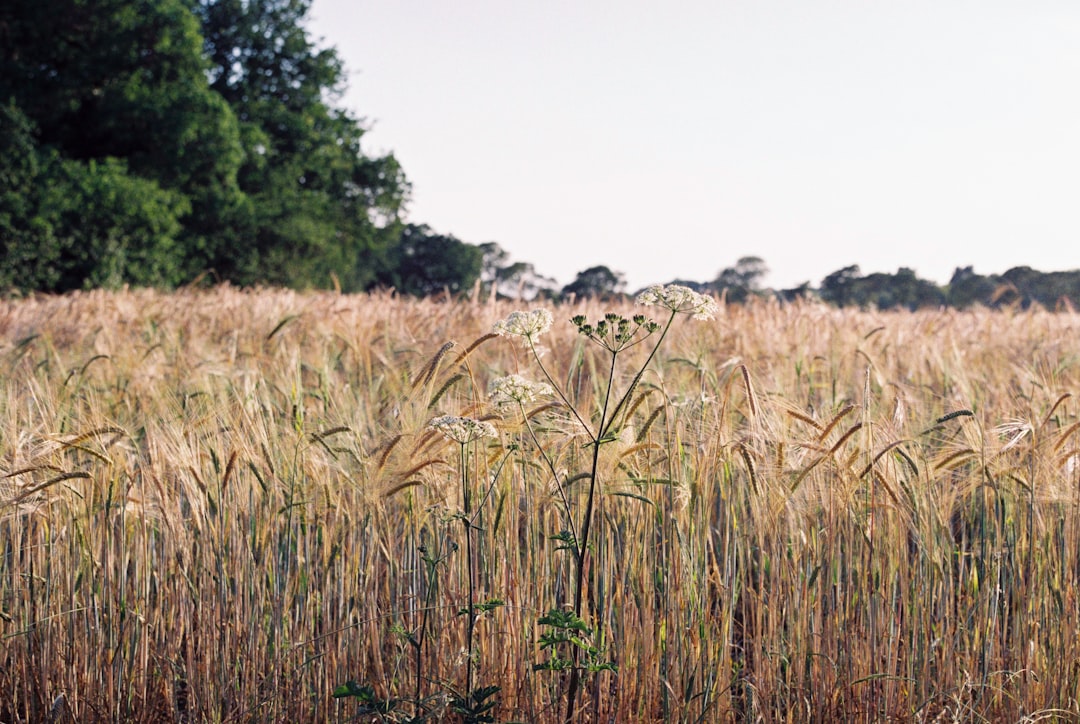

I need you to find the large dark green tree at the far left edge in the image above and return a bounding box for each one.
[0,0,241,291]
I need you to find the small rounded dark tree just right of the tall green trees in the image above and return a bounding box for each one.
[378,224,484,296]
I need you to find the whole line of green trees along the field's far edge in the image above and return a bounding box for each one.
[0,0,1080,309]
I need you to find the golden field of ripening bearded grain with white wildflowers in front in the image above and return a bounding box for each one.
[0,287,1080,723]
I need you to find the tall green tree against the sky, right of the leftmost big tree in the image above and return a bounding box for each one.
[188,0,409,291]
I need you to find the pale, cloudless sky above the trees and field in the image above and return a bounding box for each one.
[309,0,1080,291]
